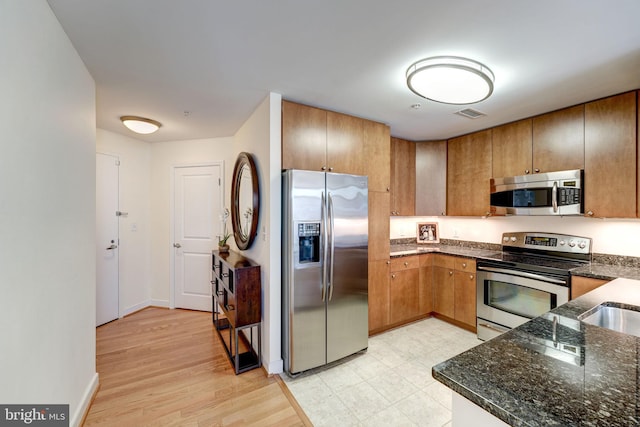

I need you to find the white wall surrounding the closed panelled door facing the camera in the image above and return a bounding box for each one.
[150,137,237,307]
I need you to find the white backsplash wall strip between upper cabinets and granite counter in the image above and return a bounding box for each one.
[391,216,640,257]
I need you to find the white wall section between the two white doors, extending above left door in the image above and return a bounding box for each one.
[96,129,151,317]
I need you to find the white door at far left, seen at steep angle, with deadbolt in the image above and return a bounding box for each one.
[96,153,120,326]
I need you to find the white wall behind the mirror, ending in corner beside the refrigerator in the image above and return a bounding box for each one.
[232,93,283,373]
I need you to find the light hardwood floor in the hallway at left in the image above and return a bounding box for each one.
[84,307,311,426]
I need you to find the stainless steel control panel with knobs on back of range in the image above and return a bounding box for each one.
[502,231,591,254]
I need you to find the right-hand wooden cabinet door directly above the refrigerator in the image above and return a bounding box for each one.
[327,111,364,175]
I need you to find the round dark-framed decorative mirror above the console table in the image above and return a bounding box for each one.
[231,152,260,250]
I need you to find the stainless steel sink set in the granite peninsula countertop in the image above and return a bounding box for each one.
[578,302,640,337]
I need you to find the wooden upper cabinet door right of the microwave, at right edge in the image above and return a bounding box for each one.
[584,92,637,218]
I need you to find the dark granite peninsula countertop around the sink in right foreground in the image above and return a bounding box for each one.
[432,279,640,426]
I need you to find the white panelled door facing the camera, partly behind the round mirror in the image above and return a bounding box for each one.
[173,165,223,311]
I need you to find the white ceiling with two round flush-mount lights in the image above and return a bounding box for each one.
[48,0,640,142]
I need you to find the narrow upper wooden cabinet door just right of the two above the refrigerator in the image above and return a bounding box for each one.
[364,120,391,194]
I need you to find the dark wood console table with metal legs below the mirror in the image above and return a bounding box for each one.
[211,251,262,374]
